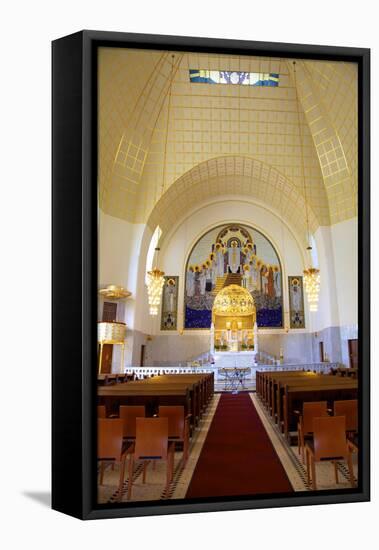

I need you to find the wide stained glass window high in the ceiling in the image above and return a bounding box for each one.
[189,69,279,86]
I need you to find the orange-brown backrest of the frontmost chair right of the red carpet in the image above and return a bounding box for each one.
[313,416,347,460]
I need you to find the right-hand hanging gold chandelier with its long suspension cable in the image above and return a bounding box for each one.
[293,61,320,311]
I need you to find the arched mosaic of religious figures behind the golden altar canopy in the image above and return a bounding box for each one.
[184,224,283,329]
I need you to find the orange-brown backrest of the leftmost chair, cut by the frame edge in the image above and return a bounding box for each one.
[97,418,124,461]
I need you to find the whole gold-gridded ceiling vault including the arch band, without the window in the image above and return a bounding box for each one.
[99,48,357,234]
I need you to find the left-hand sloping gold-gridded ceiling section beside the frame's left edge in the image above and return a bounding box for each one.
[99,48,179,221]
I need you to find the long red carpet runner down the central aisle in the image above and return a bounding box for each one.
[186,393,293,498]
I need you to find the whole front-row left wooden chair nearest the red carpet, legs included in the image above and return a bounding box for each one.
[127,418,175,500]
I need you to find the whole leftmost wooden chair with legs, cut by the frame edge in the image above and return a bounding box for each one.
[97,418,127,500]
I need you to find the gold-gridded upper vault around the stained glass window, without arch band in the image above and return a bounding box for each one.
[99,50,357,229]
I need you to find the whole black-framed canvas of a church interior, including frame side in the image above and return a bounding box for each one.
[52,31,370,519]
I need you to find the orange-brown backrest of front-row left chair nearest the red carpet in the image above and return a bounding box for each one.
[135,418,168,460]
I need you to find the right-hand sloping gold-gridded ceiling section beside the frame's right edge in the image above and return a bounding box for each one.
[290,61,358,223]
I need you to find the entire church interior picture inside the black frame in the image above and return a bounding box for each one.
[96,47,359,504]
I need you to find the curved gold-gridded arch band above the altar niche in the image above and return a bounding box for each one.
[148,156,318,248]
